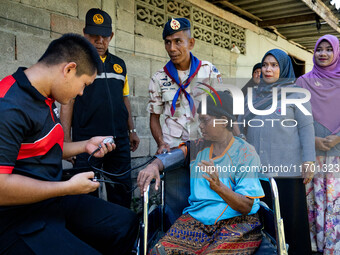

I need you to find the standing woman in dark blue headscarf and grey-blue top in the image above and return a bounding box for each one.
[238,49,315,255]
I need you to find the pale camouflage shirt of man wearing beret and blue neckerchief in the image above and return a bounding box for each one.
[147,61,222,147]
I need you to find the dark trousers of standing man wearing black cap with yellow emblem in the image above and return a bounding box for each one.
[74,137,132,208]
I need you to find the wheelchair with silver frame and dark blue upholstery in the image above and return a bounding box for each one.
[137,167,288,255]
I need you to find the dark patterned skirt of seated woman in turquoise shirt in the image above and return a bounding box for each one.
[150,214,262,255]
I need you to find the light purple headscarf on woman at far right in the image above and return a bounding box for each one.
[296,35,340,134]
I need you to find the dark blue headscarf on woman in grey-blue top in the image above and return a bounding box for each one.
[244,49,295,121]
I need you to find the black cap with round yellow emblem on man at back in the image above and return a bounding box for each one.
[84,8,112,37]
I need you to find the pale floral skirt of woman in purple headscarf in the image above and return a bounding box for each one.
[306,156,340,255]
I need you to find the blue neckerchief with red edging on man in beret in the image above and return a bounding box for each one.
[163,52,202,116]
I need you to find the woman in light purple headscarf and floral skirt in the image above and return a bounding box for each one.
[297,35,340,254]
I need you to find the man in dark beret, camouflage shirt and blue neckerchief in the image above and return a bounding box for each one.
[147,18,221,153]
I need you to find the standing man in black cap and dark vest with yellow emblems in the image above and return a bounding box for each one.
[60,8,139,207]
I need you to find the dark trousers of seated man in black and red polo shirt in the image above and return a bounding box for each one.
[0,195,139,255]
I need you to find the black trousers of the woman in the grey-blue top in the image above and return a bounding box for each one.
[261,178,312,255]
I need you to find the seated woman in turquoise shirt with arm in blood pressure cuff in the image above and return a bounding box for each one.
[137,92,264,254]
